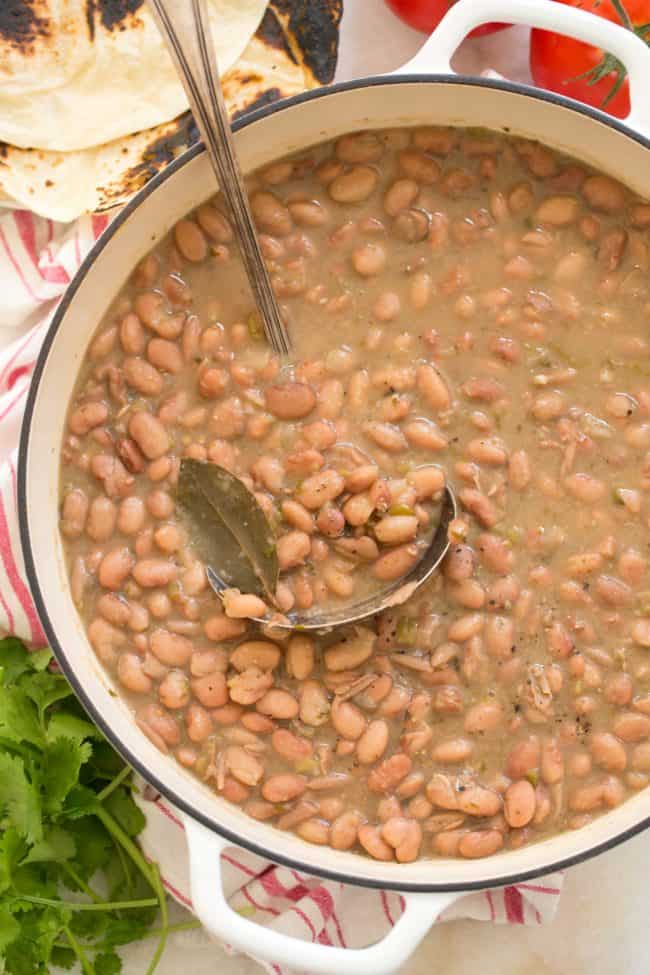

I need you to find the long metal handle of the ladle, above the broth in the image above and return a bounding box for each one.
[149,0,290,356]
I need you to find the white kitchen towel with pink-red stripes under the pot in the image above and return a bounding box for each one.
[0,202,562,975]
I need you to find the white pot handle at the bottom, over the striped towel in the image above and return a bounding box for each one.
[184,816,463,975]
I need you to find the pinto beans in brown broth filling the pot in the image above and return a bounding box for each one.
[61,128,650,862]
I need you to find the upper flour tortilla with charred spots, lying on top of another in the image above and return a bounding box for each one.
[0,0,266,152]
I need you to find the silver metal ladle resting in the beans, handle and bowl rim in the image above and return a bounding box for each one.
[149,0,457,631]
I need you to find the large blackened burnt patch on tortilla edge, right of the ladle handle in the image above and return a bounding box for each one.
[269,0,343,85]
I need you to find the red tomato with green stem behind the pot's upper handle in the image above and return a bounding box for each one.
[530,0,650,118]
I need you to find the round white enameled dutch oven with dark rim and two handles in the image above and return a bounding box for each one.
[19,0,650,975]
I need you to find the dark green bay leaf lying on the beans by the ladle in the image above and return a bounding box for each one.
[177,457,279,598]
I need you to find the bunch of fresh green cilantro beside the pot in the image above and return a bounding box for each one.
[0,637,198,975]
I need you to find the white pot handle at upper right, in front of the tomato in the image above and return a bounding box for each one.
[395,0,650,136]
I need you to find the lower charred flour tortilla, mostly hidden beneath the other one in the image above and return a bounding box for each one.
[0,0,342,221]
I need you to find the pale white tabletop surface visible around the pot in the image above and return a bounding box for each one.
[13,0,650,975]
